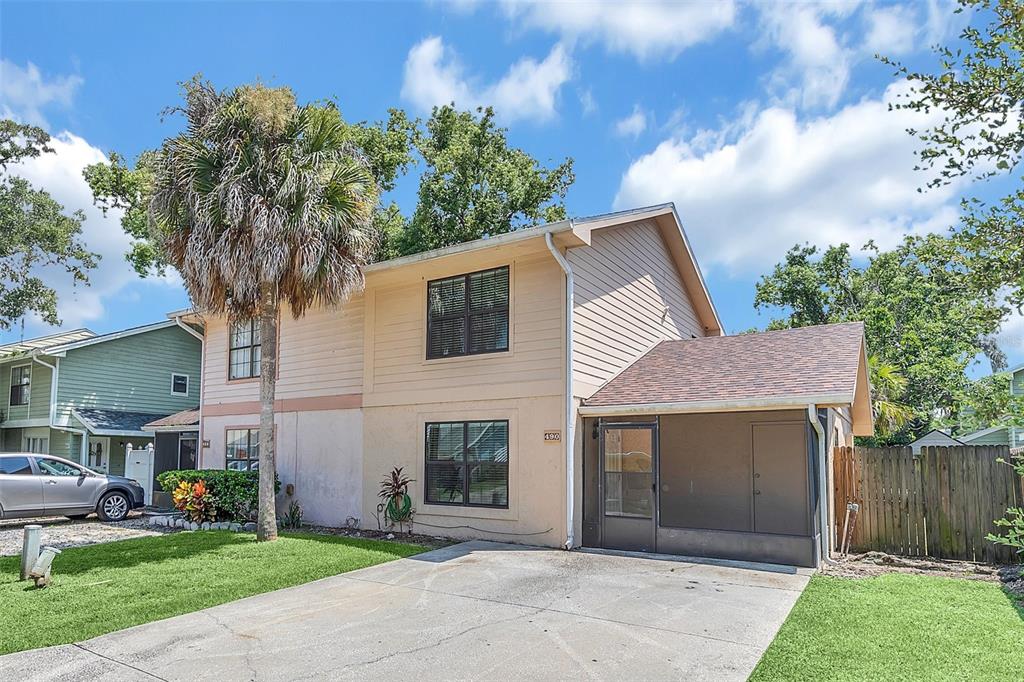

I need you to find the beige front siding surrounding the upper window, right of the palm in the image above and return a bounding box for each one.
[364,254,564,406]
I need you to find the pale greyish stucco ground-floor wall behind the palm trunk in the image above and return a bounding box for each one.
[200,410,362,526]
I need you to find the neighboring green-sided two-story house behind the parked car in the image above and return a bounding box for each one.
[0,318,203,474]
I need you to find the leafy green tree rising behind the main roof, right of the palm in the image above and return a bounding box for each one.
[398,105,575,254]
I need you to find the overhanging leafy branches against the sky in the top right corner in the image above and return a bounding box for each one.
[883,0,1024,307]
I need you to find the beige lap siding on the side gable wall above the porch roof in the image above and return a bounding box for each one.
[568,221,705,397]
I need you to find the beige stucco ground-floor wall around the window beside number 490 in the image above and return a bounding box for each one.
[362,396,565,547]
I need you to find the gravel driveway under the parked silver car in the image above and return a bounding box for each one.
[0,512,173,556]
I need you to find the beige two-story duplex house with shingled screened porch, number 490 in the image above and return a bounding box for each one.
[188,205,871,564]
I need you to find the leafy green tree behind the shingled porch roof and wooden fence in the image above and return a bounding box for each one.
[755,235,1006,442]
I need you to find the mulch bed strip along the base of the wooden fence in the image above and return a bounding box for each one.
[821,552,1024,606]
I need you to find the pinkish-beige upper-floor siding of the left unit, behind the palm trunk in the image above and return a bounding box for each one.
[203,296,364,404]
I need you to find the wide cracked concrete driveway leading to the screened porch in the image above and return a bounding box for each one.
[0,542,808,682]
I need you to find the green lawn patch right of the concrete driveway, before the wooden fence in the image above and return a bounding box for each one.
[751,573,1024,682]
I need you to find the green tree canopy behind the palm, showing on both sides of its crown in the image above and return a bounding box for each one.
[84,102,574,275]
